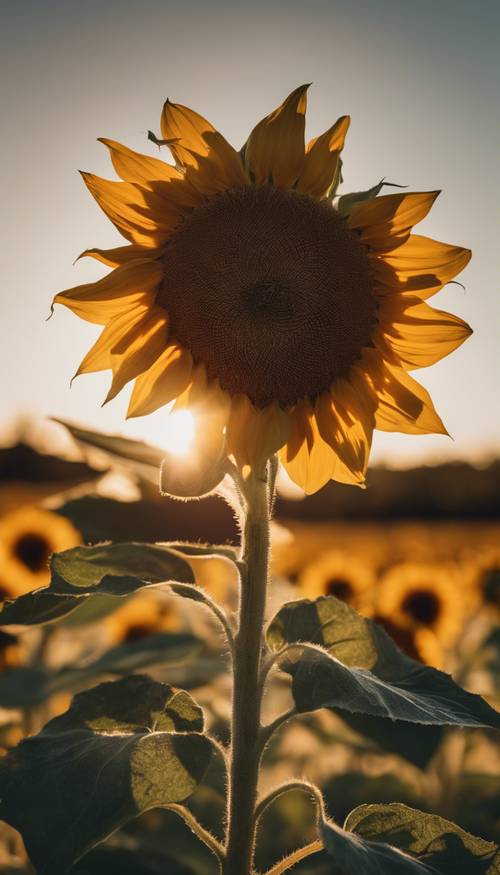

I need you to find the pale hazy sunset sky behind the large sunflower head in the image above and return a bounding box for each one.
[0,0,500,466]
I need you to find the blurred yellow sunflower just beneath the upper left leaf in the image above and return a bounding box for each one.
[102,591,182,646]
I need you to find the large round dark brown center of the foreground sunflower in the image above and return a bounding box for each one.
[158,186,376,407]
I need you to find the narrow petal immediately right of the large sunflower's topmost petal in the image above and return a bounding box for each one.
[297,115,351,197]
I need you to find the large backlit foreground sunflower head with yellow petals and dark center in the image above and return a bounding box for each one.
[54,85,470,493]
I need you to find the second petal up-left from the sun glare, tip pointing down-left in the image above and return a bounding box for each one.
[105,307,168,403]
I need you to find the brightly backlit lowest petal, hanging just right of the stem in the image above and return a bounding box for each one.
[280,400,364,495]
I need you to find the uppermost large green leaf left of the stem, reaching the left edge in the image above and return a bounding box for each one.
[0,543,194,626]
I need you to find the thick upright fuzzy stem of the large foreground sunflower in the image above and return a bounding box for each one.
[223,462,270,875]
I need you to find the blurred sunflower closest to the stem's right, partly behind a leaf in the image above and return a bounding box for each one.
[297,550,375,613]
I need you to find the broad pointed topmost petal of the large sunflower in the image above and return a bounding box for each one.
[244,85,309,188]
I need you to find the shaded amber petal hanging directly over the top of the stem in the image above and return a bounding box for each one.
[227,395,290,469]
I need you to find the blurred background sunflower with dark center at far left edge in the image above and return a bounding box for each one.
[0,506,82,599]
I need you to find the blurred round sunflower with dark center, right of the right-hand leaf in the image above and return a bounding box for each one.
[375,562,469,665]
